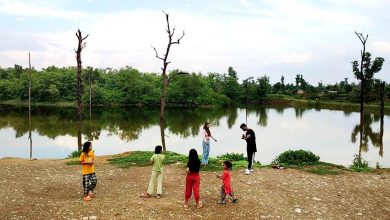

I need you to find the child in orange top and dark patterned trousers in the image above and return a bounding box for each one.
[80,141,97,201]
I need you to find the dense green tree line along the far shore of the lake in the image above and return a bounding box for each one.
[0,65,390,106]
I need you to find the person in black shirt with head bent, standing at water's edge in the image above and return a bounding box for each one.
[240,124,257,175]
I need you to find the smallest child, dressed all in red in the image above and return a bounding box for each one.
[217,160,238,205]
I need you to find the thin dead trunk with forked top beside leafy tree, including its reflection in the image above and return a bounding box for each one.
[355,31,368,157]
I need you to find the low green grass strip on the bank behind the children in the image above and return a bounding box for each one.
[108,151,261,171]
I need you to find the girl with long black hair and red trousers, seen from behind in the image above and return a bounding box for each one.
[184,149,202,209]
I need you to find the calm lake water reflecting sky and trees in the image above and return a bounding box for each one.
[0,105,390,167]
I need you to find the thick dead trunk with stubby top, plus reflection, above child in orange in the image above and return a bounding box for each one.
[74,29,89,150]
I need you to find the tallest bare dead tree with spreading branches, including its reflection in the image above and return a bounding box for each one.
[152,11,185,151]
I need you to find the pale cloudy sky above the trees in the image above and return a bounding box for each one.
[0,0,390,85]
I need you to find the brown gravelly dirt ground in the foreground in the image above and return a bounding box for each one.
[0,157,390,219]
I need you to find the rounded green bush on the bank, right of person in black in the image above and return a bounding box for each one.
[273,150,320,165]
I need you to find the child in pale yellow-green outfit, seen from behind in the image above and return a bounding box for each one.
[140,145,165,199]
